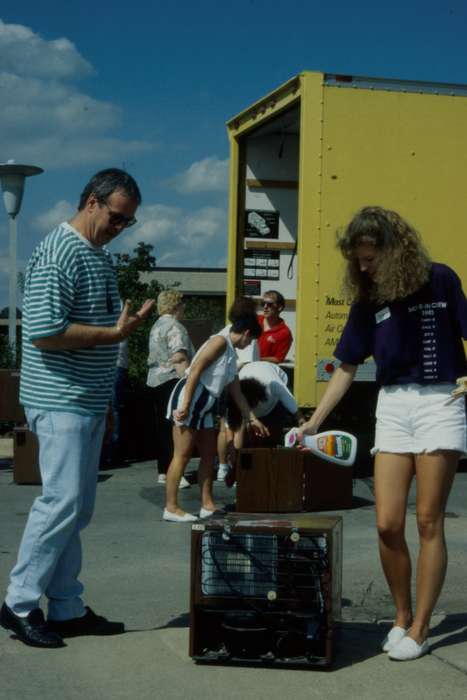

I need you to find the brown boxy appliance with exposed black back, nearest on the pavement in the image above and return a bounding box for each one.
[190,513,342,668]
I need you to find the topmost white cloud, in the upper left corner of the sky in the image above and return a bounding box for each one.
[0,20,94,79]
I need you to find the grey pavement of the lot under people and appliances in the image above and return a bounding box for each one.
[0,459,467,700]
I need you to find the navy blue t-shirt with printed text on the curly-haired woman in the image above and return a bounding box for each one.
[334,263,467,385]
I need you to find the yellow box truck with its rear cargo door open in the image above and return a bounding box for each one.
[227,72,467,460]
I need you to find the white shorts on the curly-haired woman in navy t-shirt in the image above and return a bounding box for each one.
[371,383,467,456]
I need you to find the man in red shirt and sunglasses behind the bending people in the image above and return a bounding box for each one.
[258,289,293,364]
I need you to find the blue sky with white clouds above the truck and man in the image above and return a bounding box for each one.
[0,0,467,307]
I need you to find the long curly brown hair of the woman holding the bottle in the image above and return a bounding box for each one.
[337,206,431,303]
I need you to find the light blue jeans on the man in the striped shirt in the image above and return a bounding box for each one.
[5,409,105,620]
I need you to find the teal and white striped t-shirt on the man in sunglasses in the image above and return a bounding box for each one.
[20,223,120,415]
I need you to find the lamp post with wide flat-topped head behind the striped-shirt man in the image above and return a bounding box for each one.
[0,160,44,359]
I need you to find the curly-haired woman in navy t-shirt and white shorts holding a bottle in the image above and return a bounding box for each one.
[299,207,467,661]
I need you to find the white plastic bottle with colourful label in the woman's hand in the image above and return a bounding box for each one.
[284,428,357,467]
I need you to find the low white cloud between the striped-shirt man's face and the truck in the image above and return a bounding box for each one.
[117,204,227,267]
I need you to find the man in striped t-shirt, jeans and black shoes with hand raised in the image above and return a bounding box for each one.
[0,169,154,647]
